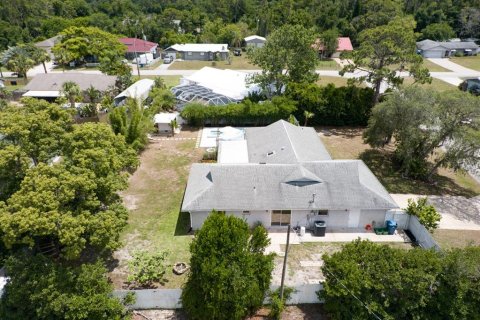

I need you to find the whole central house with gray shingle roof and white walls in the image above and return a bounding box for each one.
[182,120,398,229]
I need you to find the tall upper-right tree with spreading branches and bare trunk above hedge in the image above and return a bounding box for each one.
[340,18,431,104]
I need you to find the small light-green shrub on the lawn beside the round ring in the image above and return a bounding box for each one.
[127,251,167,287]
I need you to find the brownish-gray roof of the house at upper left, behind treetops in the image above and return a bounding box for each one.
[24,72,116,91]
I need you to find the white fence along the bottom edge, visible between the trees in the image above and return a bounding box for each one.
[113,283,323,310]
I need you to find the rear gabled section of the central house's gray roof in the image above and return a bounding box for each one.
[245,120,332,163]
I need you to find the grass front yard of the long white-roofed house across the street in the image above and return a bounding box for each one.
[168,53,260,70]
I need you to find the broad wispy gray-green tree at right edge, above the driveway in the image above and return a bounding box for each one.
[364,86,480,179]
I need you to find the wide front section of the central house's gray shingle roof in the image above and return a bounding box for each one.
[182,160,398,211]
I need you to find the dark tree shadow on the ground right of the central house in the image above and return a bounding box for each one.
[359,149,476,198]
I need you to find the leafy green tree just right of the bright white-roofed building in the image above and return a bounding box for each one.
[247,25,318,95]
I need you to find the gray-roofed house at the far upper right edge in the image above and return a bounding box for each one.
[417,39,480,58]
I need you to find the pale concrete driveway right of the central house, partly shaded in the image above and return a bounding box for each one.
[391,194,480,230]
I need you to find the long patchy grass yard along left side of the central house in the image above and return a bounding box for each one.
[110,130,201,288]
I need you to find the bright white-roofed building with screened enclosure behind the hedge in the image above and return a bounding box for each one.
[172,67,260,107]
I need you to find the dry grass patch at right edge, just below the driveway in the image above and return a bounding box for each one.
[433,229,480,249]
